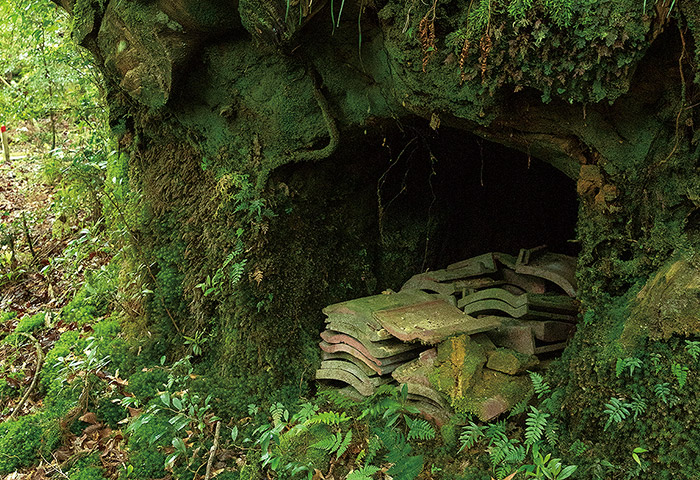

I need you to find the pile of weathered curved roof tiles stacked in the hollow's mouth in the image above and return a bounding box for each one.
[316,247,578,420]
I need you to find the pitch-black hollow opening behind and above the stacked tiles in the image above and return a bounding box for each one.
[377,122,578,284]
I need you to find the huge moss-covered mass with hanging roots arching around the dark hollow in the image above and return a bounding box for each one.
[56,0,700,478]
